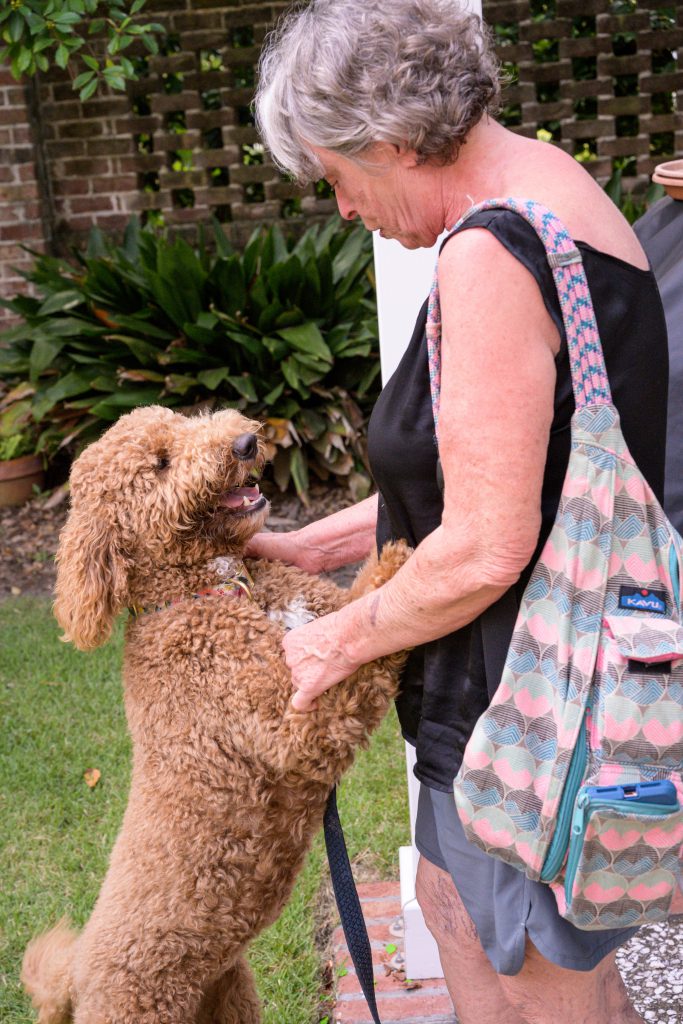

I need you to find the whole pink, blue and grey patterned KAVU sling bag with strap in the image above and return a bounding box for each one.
[427,199,683,930]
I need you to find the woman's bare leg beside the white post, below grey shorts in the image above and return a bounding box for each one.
[416,857,528,1024]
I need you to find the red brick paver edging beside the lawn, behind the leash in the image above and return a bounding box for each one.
[331,882,457,1024]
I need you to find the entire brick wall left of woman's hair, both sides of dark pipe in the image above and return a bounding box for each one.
[0,0,334,326]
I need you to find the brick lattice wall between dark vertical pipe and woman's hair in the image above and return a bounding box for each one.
[32,0,334,244]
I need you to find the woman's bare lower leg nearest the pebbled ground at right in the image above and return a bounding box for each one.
[499,939,643,1024]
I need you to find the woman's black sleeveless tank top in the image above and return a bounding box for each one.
[368,210,668,791]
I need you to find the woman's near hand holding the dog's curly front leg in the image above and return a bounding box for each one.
[283,613,358,711]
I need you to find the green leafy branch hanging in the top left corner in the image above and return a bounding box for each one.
[0,0,164,100]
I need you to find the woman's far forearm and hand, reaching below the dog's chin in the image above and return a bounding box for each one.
[246,495,377,573]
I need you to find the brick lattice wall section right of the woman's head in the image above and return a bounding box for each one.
[483,0,683,187]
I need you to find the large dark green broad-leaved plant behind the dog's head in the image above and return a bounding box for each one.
[0,217,379,498]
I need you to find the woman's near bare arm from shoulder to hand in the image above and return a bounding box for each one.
[284,228,559,711]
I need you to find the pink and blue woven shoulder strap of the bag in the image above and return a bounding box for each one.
[426,199,611,438]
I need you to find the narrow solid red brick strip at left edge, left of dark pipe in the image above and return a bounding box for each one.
[0,68,44,325]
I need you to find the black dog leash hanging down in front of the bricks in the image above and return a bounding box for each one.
[324,787,382,1024]
